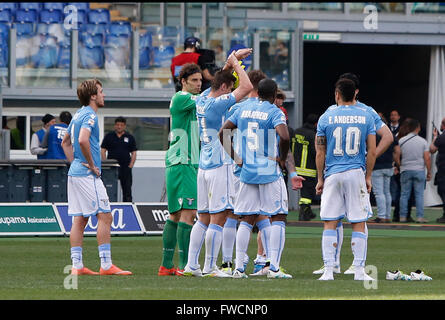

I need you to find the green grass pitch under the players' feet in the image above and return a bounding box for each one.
[0,206,445,300]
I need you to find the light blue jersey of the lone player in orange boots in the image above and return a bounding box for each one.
[67,106,101,177]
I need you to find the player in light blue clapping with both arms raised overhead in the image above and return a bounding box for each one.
[184,49,252,277]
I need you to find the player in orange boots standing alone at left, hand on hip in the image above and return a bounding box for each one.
[62,79,132,275]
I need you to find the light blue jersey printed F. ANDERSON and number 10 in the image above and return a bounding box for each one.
[317,105,374,178]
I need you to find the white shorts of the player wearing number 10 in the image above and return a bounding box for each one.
[320,169,372,223]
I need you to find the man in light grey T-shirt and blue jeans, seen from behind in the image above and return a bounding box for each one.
[396,119,431,223]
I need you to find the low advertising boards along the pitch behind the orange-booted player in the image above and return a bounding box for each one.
[0,202,169,237]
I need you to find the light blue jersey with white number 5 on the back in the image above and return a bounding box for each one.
[229,101,286,184]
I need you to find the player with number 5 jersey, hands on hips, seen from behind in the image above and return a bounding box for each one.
[219,79,304,278]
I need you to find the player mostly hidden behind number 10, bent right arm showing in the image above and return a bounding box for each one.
[313,73,394,274]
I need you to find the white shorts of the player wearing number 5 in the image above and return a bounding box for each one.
[234,177,288,216]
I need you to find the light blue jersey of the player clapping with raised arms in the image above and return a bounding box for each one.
[196,92,236,170]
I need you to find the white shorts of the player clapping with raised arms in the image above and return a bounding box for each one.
[198,164,235,213]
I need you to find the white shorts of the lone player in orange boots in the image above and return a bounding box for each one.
[67,175,111,217]
